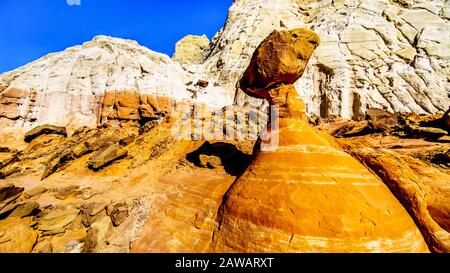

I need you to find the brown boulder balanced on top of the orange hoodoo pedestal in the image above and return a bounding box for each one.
[240,28,320,98]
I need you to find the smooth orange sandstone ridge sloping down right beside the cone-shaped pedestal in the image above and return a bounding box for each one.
[343,146,450,253]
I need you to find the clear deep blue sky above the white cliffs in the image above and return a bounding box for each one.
[0,0,232,73]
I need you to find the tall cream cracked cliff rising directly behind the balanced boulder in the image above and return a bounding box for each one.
[200,0,450,118]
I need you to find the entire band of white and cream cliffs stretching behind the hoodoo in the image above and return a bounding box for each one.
[0,0,450,133]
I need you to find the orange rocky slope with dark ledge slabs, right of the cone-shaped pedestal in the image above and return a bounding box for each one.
[317,110,450,253]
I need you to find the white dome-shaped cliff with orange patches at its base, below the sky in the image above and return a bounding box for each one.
[0,36,232,136]
